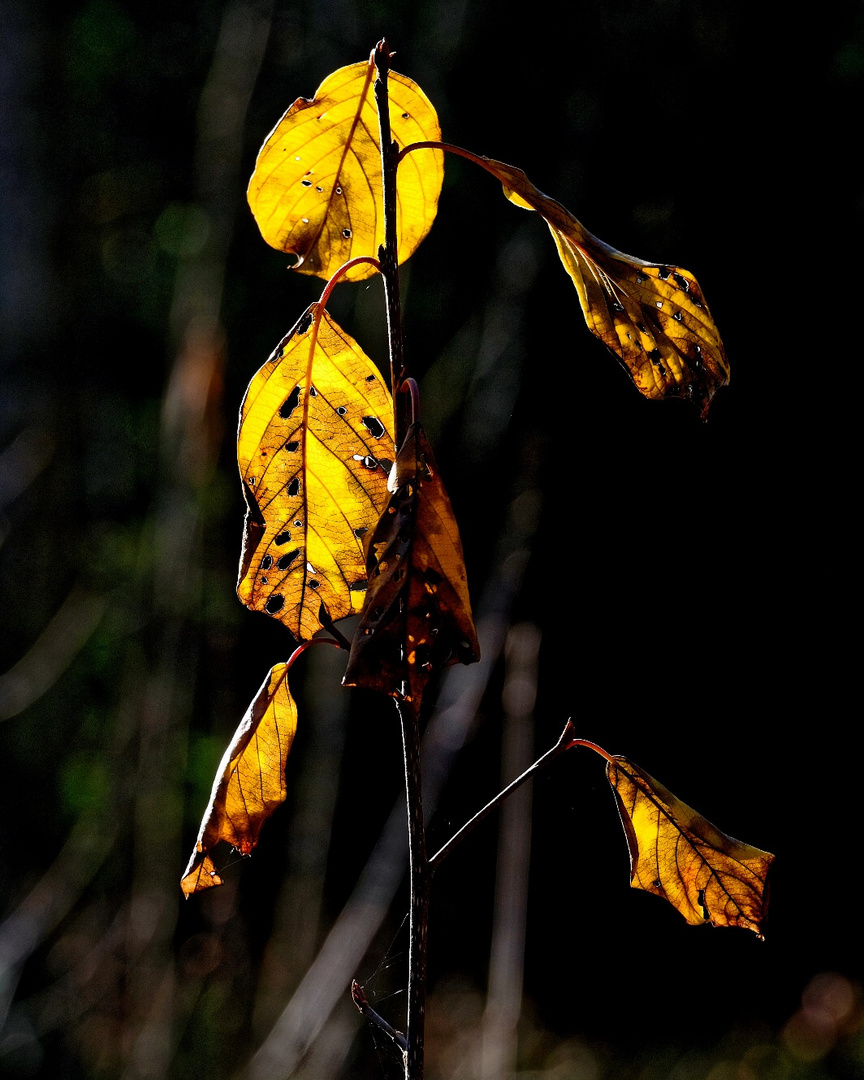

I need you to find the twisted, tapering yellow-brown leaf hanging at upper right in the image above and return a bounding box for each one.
[486,156,729,417]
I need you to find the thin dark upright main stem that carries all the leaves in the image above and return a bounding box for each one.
[374,40,432,1080]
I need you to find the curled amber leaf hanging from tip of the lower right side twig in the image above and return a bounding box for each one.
[606,756,774,936]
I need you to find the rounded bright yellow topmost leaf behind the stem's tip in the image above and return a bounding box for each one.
[248,63,444,281]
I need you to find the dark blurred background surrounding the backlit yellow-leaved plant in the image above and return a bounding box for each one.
[0,0,864,1080]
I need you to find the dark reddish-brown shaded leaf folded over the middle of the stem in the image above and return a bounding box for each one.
[342,423,480,710]
